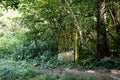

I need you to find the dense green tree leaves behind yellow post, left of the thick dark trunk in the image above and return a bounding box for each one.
[0,0,119,61]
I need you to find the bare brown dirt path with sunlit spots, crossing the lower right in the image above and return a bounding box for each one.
[45,68,120,80]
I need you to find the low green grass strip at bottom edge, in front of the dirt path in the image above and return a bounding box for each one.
[30,73,103,80]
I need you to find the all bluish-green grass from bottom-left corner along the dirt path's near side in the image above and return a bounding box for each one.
[0,59,111,80]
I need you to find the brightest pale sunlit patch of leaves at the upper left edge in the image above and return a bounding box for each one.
[0,8,21,35]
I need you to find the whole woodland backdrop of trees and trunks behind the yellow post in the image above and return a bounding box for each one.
[1,0,120,59]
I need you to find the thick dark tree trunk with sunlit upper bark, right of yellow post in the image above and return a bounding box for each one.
[96,0,109,60]
